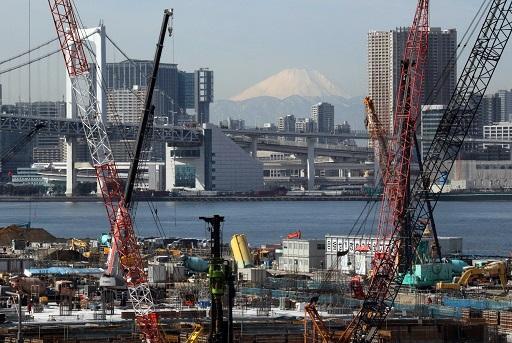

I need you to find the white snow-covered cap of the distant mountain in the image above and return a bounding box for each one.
[231,69,349,101]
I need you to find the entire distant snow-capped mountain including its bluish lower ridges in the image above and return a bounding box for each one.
[210,69,364,129]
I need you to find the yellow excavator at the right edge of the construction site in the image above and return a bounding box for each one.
[436,261,508,292]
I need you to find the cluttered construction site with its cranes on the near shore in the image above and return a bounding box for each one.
[0,0,512,343]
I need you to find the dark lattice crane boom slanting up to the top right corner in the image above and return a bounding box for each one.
[339,0,512,342]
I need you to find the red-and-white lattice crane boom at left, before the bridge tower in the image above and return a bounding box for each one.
[48,0,165,342]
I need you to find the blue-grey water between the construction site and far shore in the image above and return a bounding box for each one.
[0,201,512,255]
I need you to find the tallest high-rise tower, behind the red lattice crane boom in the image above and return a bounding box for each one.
[368,27,457,131]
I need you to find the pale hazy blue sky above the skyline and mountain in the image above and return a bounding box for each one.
[0,0,512,102]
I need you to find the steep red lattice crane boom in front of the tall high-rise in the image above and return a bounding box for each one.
[340,0,429,342]
